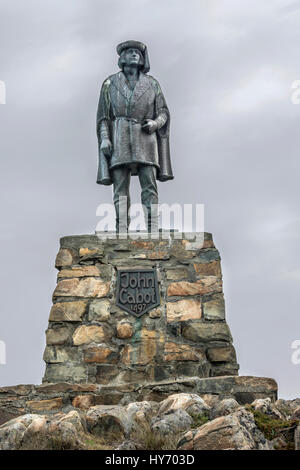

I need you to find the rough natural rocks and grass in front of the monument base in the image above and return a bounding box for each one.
[0,393,300,450]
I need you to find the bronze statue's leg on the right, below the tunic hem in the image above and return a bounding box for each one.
[138,165,158,232]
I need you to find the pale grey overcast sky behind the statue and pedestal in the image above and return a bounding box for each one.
[0,0,300,398]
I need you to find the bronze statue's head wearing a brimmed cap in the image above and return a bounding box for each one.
[117,41,150,73]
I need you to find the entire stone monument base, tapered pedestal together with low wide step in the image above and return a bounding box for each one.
[0,232,277,430]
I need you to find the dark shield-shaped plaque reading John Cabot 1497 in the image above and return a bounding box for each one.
[116,269,160,317]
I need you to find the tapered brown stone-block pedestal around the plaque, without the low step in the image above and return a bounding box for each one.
[43,233,238,386]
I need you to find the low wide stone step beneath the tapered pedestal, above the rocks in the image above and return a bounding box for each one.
[0,376,277,425]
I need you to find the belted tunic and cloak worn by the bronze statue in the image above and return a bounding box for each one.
[97,72,173,184]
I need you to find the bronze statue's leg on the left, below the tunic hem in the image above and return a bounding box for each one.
[111,166,131,233]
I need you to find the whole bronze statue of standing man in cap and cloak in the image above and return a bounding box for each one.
[97,41,173,232]
